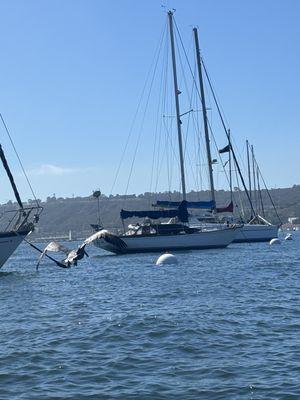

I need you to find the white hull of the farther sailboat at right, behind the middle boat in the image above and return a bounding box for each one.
[233,224,278,243]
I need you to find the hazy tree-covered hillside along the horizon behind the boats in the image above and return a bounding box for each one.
[1,185,300,237]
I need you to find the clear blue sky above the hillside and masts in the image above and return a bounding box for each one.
[0,0,300,201]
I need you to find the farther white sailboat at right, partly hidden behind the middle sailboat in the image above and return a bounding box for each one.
[156,28,281,243]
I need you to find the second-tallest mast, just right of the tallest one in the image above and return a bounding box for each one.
[193,28,216,209]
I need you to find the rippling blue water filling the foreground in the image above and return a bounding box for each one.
[0,232,300,400]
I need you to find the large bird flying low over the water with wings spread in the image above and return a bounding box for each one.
[36,229,126,269]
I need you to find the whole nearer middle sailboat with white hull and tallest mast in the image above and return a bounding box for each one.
[94,11,237,254]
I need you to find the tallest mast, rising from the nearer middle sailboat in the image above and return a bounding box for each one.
[168,10,186,200]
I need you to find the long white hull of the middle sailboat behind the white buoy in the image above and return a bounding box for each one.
[94,228,236,254]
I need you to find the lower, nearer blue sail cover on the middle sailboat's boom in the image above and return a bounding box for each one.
[120,201,188,222]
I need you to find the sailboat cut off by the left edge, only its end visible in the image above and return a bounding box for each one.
[0,119,42,268]
